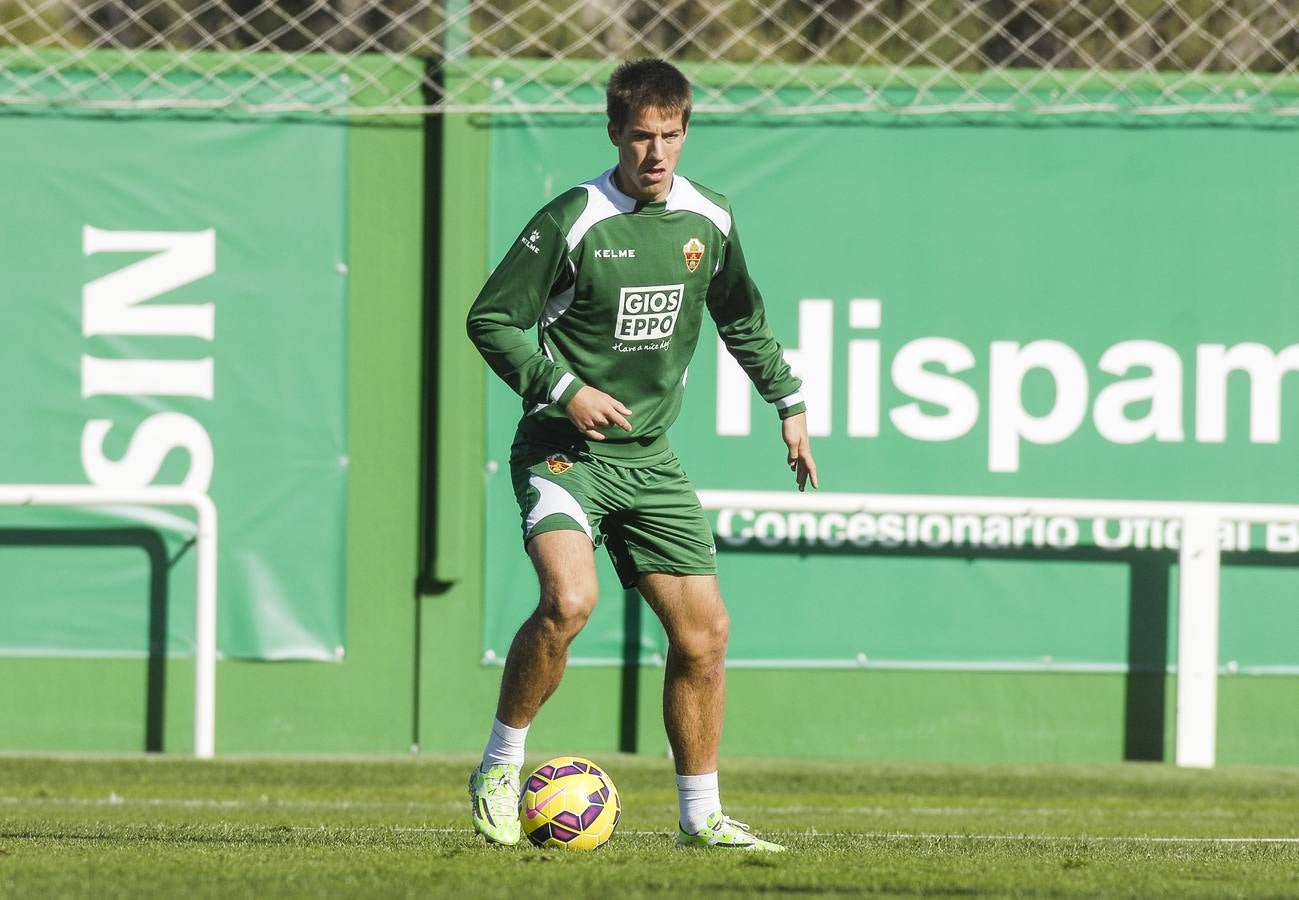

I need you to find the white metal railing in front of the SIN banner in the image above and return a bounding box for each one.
[0,484,217,760]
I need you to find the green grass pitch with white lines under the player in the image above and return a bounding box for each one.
[0,755,1299,900]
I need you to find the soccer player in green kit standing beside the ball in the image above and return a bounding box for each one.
[468,60,817,851]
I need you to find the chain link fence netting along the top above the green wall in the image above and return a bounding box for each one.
[0,0,1299,117]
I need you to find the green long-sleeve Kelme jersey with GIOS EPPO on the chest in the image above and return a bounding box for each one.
[468,169,804,461]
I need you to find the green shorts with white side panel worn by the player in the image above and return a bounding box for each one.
[509,440,717,588]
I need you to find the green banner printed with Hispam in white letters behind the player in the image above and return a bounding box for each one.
[485,109,1299,673]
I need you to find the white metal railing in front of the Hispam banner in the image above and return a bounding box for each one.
[699,491,1299,769]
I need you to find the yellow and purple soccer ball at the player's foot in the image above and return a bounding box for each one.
[518,756,622,849]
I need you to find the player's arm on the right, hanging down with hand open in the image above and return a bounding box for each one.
[708,223,820,491]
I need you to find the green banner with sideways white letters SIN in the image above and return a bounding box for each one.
[0,105,348,660]
